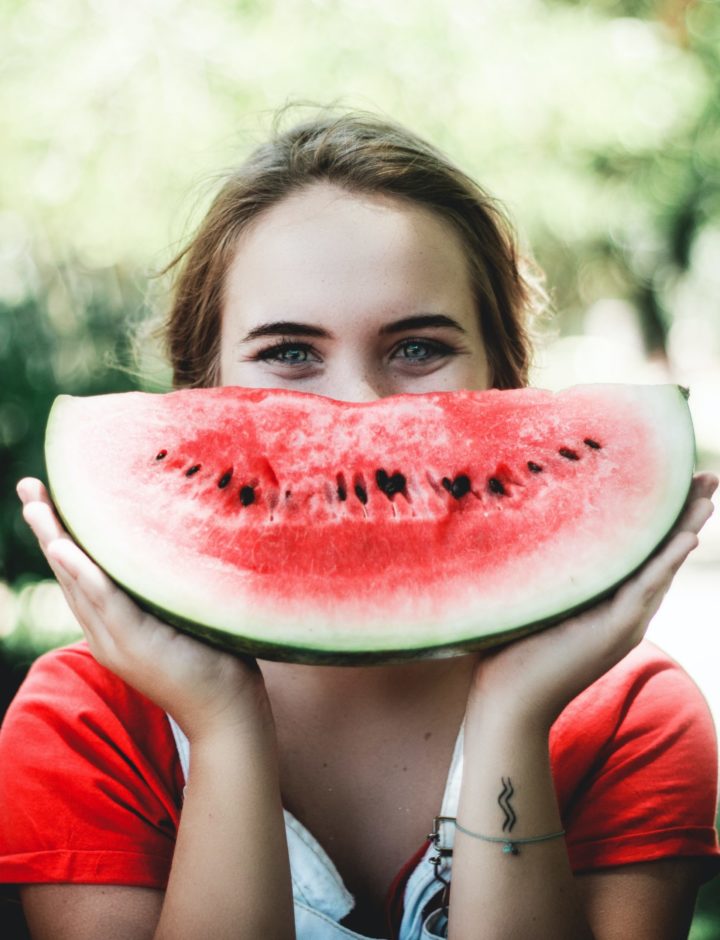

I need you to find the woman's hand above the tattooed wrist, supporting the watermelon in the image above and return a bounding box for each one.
[471,473,718,729]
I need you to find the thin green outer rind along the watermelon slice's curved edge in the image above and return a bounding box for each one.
[46,386,695,665]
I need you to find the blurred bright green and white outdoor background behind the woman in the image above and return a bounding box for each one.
[0,0,720,940]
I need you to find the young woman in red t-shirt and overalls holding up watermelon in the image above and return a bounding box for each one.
[0,114,718,940]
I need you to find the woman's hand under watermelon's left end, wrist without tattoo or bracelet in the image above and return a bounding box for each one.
[17,478,270,741]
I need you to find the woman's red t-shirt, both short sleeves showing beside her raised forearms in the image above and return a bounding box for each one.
[0,642,720,888]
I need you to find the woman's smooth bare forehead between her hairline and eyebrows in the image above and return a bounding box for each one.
[225,183,474,320]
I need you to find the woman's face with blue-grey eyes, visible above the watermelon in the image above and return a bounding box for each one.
[220,183,490,401]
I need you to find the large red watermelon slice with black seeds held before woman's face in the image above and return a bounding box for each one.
[46,385,694,663]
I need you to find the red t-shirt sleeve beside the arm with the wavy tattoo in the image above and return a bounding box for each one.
[550,641,720,877]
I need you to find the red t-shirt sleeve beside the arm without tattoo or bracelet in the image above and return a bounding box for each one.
[0,644,182,888]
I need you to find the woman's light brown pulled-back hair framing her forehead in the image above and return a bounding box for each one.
[164,111,536,388]
